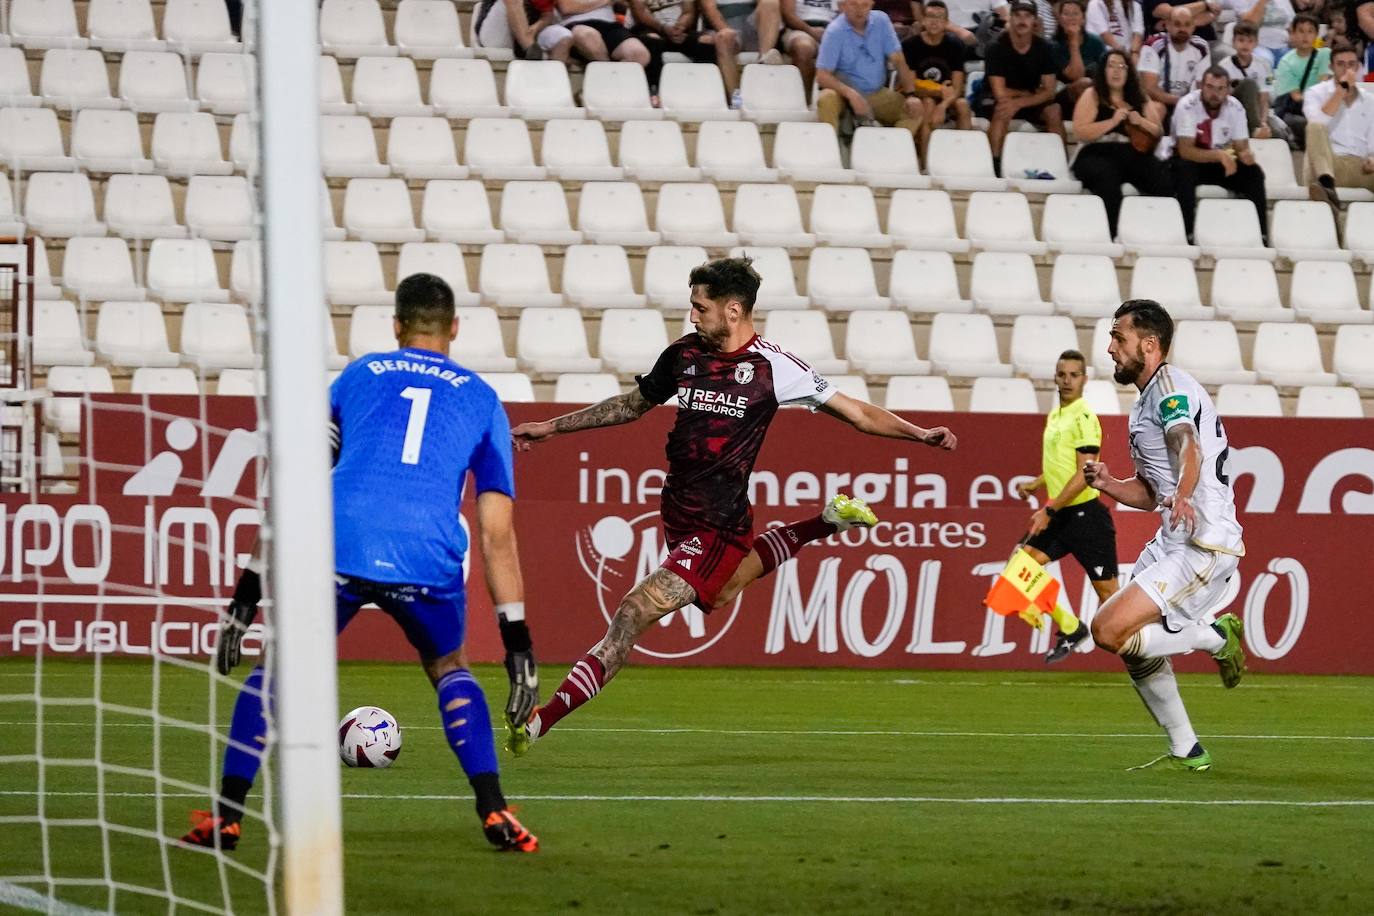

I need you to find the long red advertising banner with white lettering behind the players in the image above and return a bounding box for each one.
[0,396,1374,674]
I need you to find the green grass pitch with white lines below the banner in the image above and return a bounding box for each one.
[0,659,1374,916]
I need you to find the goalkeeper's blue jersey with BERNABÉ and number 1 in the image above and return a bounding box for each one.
[330,349,515,588]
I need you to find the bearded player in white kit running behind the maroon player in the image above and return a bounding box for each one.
[1083,299,1245,770]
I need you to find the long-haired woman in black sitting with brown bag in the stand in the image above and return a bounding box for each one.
[1073,51,1173,239]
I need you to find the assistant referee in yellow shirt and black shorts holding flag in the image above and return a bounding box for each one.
[1017,350,1120,665]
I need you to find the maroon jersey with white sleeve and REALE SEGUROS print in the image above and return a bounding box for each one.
[638,334,835,536]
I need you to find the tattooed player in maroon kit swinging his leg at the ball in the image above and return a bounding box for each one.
[506,258,956,755]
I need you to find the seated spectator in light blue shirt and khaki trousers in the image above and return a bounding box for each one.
[816,0,922,141]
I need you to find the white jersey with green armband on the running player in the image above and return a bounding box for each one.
[1128,364,1245,556]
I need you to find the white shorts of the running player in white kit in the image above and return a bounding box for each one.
[1131,536,1241,630]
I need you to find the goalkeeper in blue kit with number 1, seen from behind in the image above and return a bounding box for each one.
[181,273,539,853]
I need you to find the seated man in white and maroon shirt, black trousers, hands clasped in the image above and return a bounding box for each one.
[1172,67,1270,244]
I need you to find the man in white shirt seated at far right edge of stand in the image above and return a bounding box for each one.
[1303,44,1374,209]
